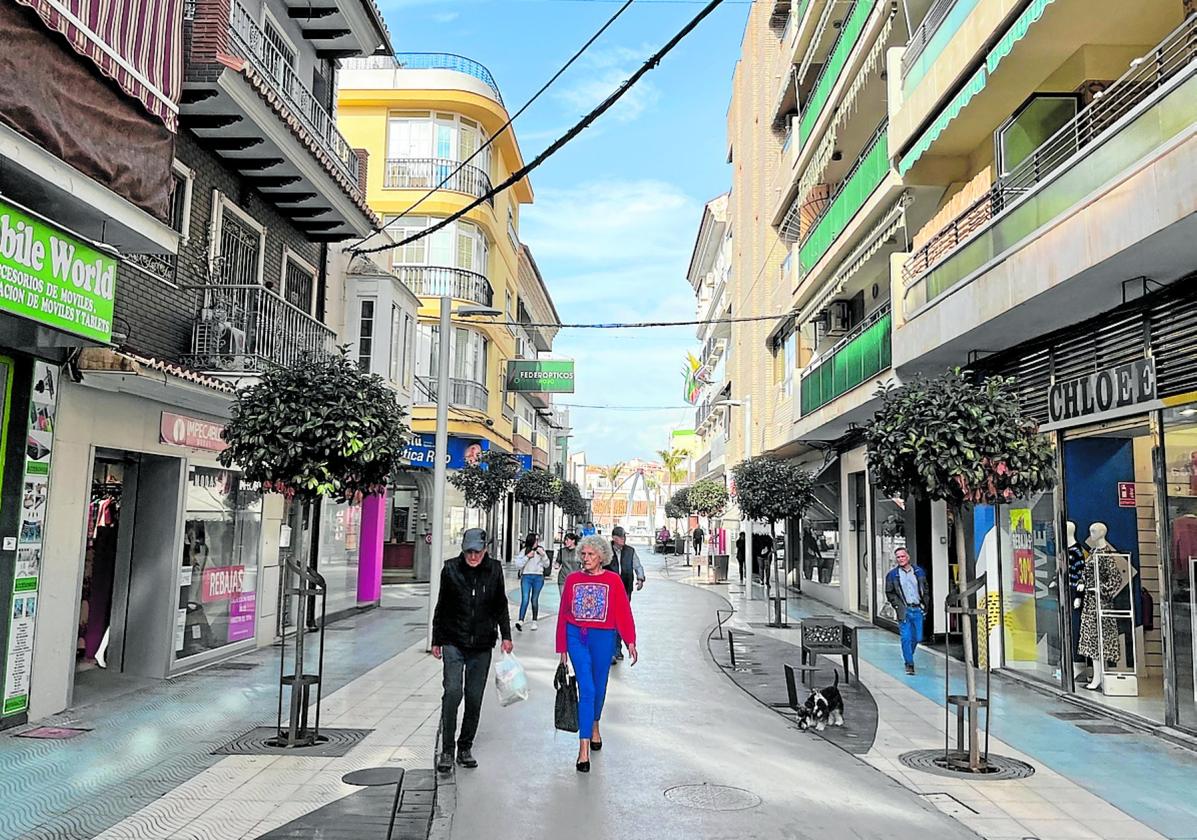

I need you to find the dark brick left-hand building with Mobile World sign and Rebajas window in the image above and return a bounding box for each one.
[0,0,402,728]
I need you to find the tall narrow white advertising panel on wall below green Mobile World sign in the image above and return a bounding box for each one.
[2,361,57,716]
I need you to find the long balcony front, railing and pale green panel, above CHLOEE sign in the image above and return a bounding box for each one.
[903,17,1197,318]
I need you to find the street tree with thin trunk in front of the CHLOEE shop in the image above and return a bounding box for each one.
[864,369,1056,773]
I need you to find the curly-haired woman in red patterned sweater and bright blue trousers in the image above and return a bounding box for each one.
[557,536,639,773]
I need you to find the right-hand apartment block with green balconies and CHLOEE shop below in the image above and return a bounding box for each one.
[689,0,1197,734]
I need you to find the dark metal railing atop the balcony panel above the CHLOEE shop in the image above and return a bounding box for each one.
[903,16,1197,286]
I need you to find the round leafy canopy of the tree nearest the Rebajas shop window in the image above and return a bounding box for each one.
[220,351,411,503]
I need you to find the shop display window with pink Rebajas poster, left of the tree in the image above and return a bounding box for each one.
[175,465,262,659]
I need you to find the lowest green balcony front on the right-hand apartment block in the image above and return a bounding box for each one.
[800,304,893,416]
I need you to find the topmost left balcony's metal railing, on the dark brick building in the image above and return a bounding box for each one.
[229,1,359,188]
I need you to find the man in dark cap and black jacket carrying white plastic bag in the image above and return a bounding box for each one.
[432,528,511,773]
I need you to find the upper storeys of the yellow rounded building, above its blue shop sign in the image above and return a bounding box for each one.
[338,54,533,451]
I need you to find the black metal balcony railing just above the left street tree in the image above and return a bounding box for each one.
[188,285,336,373]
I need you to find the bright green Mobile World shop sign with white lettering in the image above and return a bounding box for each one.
[0,201,116,343]
